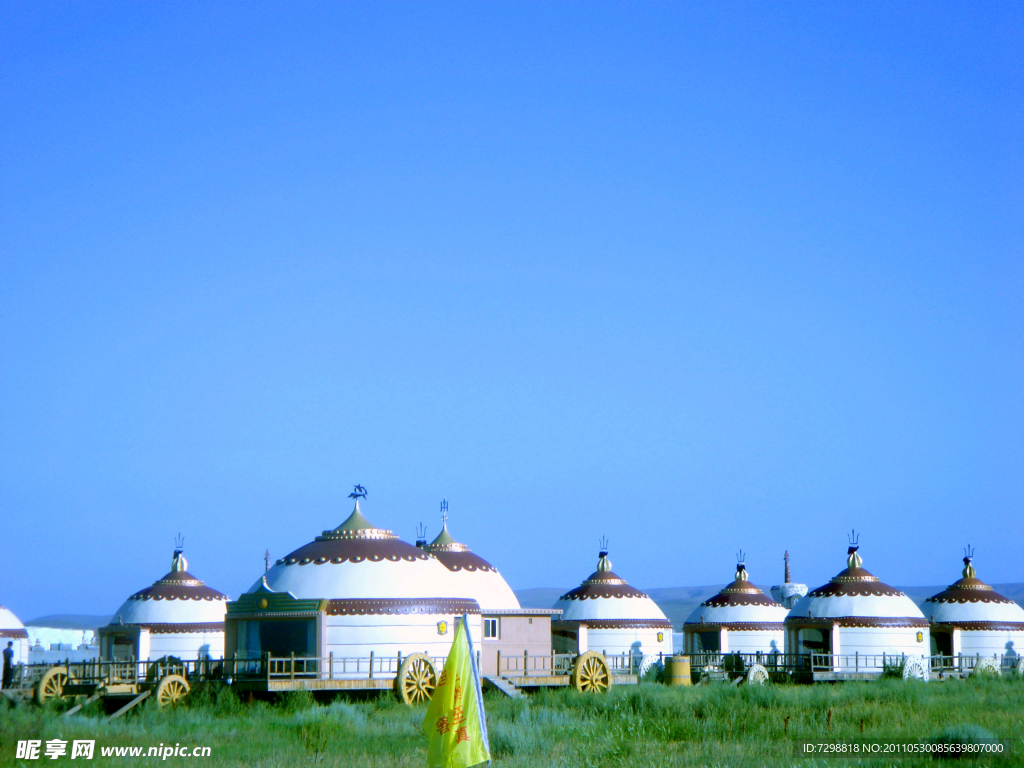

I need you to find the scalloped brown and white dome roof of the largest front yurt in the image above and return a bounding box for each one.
[256,498,479,600]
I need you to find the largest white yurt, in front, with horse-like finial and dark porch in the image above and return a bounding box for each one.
[227,488,480,678]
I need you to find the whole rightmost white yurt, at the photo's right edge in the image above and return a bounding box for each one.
[924,548,1024,667]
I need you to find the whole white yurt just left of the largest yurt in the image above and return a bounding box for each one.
[98,544,227,662]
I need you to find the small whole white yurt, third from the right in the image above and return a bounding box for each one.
[683,553,790,653]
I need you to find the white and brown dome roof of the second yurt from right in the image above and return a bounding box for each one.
[785,542,928,627]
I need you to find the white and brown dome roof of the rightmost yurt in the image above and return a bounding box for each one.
[925,547,1024,630]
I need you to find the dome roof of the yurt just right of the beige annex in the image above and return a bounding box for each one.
[554,544,672,627]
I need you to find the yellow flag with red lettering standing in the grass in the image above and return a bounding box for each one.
[423,615,490,768]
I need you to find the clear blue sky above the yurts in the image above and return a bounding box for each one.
[0,2,1024,618]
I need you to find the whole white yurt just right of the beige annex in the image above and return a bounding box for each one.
[552,542,672,657]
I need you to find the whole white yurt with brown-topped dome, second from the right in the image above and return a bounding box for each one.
[785,537,931,673]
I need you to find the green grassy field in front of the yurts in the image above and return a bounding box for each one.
[0,678,1024,768]
